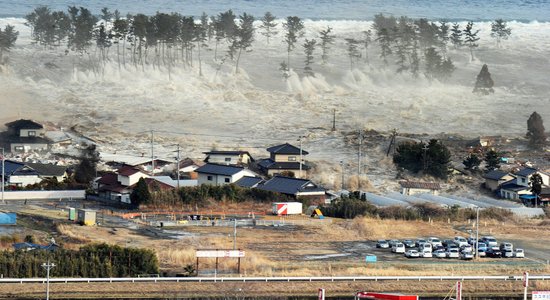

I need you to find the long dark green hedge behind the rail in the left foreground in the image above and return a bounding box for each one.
[0,244,159,278]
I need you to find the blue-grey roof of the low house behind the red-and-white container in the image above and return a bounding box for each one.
[257,176,326,195]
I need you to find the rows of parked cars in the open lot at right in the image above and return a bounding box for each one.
[376,236,525,260]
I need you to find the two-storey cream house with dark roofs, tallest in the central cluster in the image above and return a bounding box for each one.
[258,143,310,178]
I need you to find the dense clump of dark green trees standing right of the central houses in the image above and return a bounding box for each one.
[393,139,451,179]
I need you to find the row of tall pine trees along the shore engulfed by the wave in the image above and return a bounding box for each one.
[6,6,511,80]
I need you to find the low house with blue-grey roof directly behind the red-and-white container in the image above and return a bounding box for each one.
[256,175,326,203]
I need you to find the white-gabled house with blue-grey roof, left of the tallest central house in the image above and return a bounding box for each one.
[196,163,256,185]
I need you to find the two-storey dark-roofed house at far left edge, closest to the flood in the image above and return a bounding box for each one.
[0,119,50,152]
